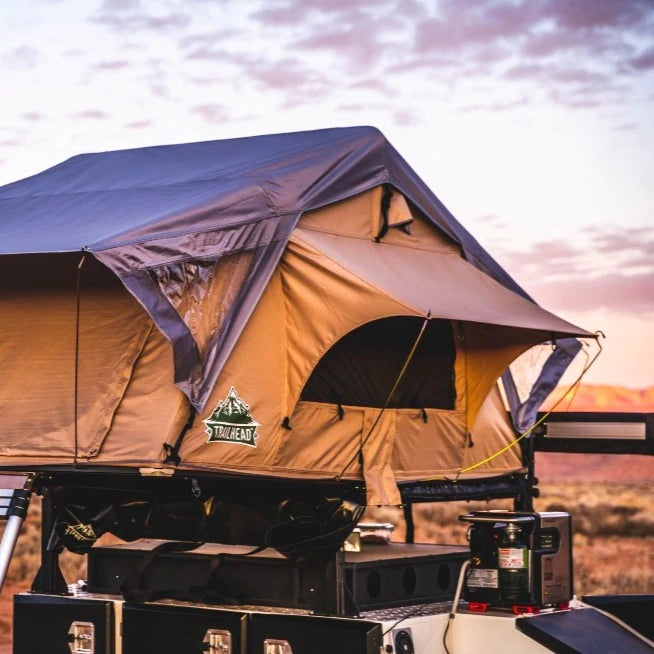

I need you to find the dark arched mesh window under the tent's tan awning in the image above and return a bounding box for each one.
[300,316,455,409]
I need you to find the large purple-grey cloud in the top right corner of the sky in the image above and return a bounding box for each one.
[392,0,654,110]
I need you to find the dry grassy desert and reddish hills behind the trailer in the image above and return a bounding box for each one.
[0,386,654,654]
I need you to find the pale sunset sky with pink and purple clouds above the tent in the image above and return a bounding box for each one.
[0,0,654,388]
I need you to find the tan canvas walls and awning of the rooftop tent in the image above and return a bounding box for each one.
[0,186,588,504]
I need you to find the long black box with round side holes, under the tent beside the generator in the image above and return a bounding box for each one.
[88,541,468,614]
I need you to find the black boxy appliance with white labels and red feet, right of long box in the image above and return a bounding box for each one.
[459,511,572,613]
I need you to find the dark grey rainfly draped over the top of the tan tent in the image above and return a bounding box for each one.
[0,127,552,410]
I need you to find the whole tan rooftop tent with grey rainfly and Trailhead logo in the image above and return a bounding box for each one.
[0,128,589,503]
